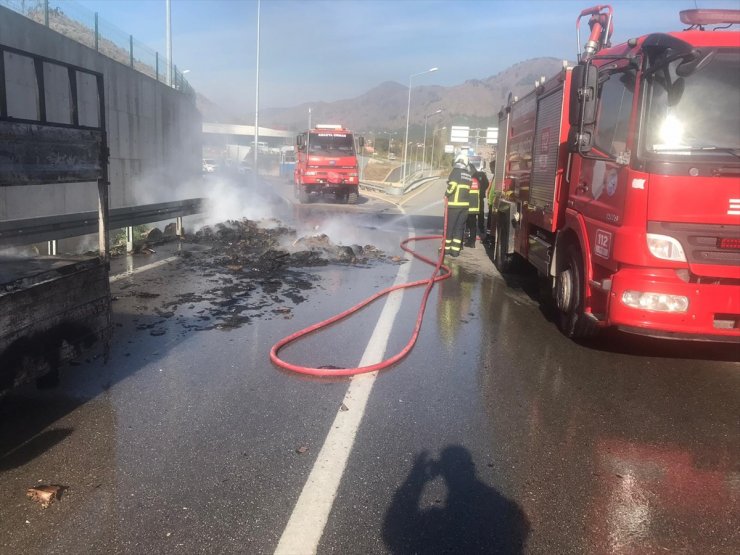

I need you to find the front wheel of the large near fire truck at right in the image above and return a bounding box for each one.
[553,243,599,339]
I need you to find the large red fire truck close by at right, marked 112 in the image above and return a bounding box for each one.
[491,6,740,341]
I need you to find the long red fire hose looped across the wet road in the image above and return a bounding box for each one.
[270,199,450,376]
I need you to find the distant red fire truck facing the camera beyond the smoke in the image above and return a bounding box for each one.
[294,125,364,204]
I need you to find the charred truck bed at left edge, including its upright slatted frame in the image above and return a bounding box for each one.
[0,43,111,396]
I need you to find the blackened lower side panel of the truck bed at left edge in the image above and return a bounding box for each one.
[0,256,111,396]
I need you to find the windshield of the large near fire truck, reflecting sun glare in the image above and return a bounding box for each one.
[643,49,740,157]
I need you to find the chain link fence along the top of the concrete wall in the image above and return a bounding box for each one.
[0,0,195,98]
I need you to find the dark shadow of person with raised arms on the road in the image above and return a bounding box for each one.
[383,445,529,554]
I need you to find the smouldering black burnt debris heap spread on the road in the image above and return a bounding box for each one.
[116,219,403,335]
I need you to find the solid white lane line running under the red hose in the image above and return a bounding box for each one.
[275,207,411,555]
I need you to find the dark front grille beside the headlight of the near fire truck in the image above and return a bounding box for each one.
[648,222,740,266]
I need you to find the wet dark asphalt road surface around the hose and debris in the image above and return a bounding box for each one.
[0,175,740,554]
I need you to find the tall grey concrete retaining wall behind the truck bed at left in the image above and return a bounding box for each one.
[0,7,203,220]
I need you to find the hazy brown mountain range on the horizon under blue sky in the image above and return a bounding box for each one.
[198,58,563,136]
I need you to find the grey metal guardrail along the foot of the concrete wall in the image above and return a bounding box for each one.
[0,198,207,247]
